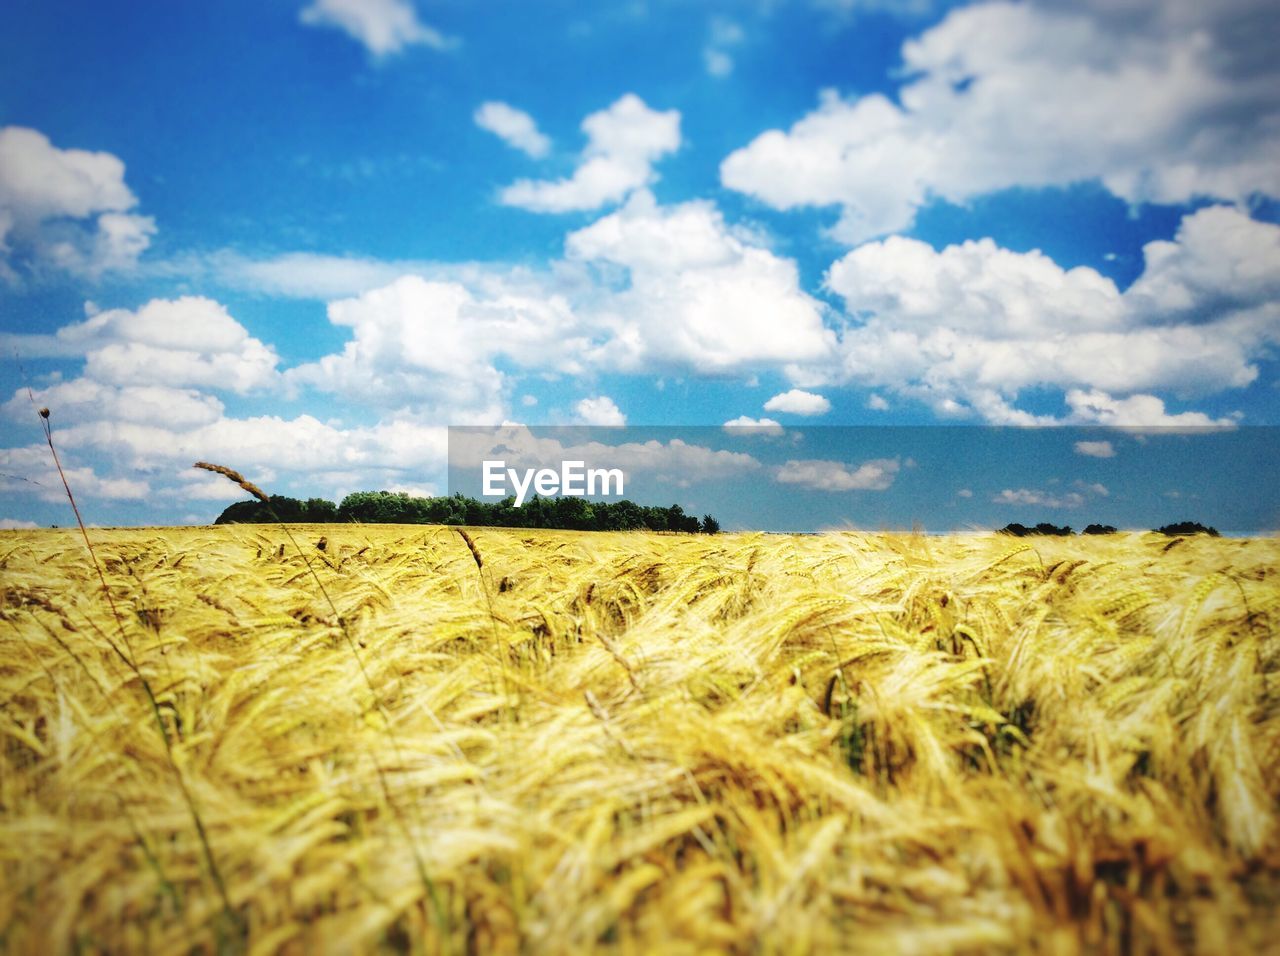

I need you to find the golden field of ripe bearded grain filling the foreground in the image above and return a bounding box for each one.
[0,525,1280,953]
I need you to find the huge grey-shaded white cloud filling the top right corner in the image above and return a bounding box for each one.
[721,0,1280,244]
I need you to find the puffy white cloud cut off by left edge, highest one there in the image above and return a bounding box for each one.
[0,127,155,282]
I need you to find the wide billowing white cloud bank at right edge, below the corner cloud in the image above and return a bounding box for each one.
[808,207,1280,425]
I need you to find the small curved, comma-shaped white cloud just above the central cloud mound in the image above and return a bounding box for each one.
[500,93,680,212]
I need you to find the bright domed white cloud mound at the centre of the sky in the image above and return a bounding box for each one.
[566,192,835,374]
